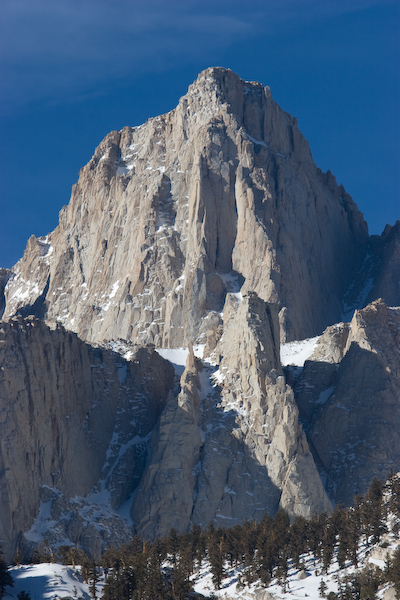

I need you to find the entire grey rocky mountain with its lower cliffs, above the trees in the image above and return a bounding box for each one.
[0,67,400,559]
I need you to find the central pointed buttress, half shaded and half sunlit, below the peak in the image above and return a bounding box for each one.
[132,294,331,538]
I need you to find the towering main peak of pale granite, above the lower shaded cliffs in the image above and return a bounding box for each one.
[5,68,368,347]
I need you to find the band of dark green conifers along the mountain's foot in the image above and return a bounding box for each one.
[0,475,400,600]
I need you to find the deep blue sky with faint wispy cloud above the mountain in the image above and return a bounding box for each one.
[0,0,400,267]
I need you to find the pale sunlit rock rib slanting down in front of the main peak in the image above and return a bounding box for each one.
[216,293,331,517]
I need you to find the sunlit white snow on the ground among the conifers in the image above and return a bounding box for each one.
[7,474,400,600]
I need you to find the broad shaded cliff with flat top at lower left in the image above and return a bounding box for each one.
[0,317,174,558]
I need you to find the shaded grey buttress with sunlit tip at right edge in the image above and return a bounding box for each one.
[294,300,400,505]
